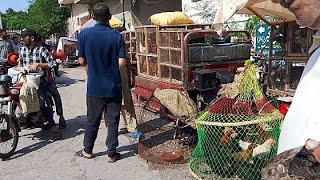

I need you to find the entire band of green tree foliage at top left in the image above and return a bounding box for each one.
[3,0,70,36]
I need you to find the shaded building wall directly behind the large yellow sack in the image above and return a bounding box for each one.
[132,0,182,25]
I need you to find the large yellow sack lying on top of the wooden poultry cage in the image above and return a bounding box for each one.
[150,12,194,26]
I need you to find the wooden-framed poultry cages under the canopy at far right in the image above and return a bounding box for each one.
[267,22,315,96]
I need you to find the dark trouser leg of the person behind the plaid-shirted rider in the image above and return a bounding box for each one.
[47,78,63,116]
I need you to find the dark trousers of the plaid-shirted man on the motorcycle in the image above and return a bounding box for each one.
[38,82,55,124]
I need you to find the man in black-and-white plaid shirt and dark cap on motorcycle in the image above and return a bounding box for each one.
[19,29,56,129]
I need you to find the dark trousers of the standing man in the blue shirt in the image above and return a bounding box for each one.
[83,96,122,157]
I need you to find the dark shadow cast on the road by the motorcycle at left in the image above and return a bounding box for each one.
[3,116,86,161]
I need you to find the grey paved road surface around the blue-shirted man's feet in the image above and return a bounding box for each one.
[0,68,192,180]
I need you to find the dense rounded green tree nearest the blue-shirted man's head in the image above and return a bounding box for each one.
[27,0,70,36]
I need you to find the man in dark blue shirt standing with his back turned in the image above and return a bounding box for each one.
[76,3,126,163]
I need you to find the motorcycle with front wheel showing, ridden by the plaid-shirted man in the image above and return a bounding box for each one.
[0,68,56,159]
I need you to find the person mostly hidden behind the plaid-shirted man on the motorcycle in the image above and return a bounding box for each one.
[38,34,67,129]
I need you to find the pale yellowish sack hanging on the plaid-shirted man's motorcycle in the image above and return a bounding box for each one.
[19,82,40,115]
